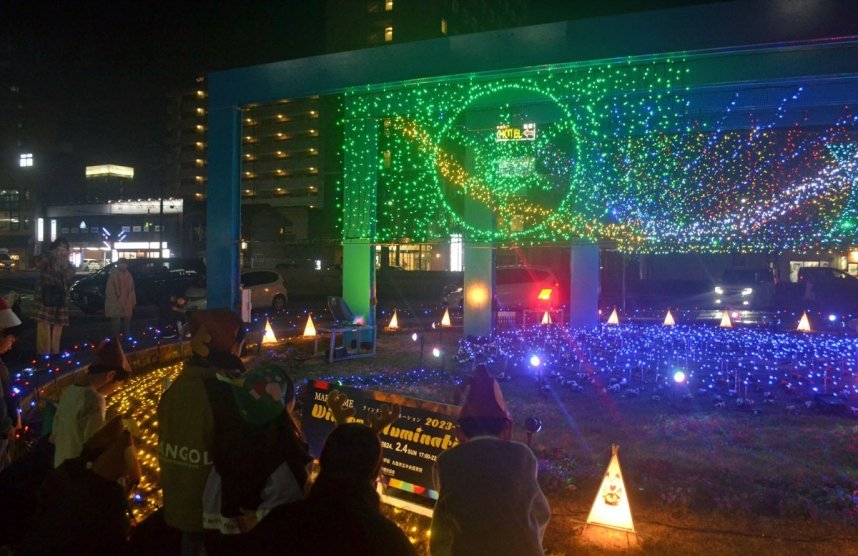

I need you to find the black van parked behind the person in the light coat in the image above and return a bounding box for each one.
[69,259,206,313]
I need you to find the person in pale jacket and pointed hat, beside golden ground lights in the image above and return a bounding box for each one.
[51,338,131,467]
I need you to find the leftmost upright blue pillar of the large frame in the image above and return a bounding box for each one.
[206,103,241,309]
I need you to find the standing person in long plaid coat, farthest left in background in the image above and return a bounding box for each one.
[33,237,74,355]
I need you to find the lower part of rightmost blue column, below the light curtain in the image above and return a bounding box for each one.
[569,242,599,328]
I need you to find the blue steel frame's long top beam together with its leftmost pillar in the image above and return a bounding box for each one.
[206,0,858,307]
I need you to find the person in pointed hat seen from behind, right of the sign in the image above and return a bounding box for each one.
[430,365,551,556]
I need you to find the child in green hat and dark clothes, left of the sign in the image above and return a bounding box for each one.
[203,363,312,556]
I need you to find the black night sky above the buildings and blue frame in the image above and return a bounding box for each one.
[0,0,724,191]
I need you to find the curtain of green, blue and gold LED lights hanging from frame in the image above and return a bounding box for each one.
[344,59,858,253]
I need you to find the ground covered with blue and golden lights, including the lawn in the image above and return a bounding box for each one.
[110,324,858,555]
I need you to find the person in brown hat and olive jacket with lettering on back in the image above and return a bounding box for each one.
[158,309,245,556]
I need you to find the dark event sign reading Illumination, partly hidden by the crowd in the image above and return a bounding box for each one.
[301,380,459,500]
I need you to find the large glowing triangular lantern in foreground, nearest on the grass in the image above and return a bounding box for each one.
[582,444,637,548]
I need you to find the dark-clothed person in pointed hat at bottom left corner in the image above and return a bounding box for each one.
[15,417,141,556]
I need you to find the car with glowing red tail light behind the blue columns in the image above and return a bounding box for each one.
[443,266,560,309]
